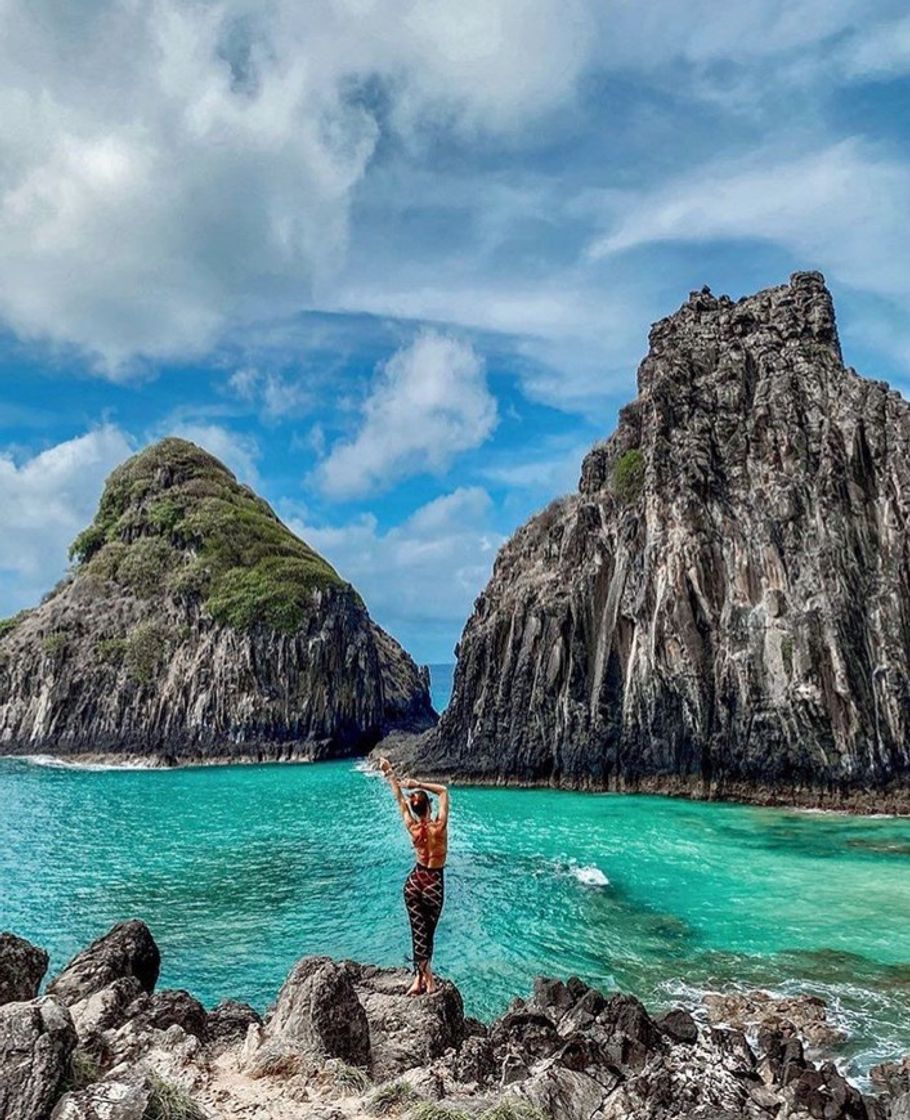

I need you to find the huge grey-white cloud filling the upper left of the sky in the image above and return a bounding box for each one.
[0,0,605,373]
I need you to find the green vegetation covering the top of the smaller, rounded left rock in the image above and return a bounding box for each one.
[71,439,349,632]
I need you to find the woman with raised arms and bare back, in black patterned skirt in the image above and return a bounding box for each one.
[379,758,448,996]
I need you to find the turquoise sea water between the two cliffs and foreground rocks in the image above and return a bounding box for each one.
[0,759,910,1070]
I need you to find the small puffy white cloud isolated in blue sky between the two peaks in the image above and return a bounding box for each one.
[316,330,496,496]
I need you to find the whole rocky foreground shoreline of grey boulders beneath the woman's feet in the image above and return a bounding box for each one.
[0,921,910,1120]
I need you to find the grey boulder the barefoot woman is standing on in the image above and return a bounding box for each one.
[355,965,466,1081]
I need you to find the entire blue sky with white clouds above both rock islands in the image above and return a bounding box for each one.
[0,0,910,662]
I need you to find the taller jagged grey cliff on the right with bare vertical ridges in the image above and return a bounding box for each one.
[405,272,910,809]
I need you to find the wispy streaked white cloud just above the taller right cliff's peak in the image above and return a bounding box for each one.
[591,140,910,298]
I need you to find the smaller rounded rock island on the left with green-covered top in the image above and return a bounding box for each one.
[0,439,435,759]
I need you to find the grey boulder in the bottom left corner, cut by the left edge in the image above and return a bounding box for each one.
[0,996,76,1120]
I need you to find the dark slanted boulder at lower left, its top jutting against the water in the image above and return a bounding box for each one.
[47,921,161,1004]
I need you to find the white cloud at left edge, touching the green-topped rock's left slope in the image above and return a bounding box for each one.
[0,424,133,613]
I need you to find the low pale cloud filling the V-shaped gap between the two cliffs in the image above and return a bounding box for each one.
[288,486,503,661]
